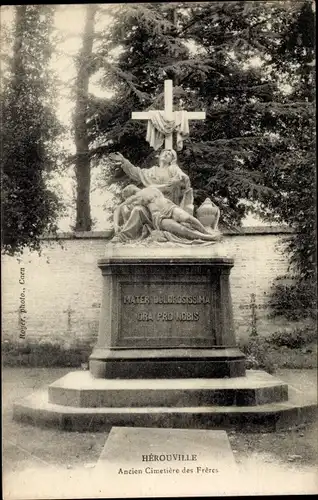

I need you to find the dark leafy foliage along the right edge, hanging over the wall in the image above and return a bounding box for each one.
[255,1,317,318]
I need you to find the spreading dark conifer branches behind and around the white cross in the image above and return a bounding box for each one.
[85,2,314,226]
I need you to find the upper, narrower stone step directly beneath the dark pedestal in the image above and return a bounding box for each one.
[48,370,288,408]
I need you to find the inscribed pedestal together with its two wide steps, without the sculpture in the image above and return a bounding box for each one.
[13,245,317,432]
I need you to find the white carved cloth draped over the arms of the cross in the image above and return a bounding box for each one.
[146,110,189,151]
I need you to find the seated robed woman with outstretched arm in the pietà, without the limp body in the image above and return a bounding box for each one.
[110,150,218,244]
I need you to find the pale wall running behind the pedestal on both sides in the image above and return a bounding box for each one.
[2,227,306,348]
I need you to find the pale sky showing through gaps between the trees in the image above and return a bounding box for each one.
[1,4,274,231]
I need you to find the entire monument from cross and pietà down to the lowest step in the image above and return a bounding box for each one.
[14,80,316,430]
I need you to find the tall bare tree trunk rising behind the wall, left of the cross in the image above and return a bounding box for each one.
[74,4,97,231]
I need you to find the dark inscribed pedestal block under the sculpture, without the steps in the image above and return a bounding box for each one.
[89,247,245,379]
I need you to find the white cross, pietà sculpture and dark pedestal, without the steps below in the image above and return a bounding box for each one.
[90,80,245,379]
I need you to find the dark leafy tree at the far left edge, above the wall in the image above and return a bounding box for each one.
[1,5,61,255]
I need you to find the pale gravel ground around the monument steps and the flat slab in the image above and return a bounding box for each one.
[2,368,318,500]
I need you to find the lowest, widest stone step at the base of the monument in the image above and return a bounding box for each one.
[13,389,317,432]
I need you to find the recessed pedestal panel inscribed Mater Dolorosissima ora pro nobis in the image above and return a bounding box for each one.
[119,281,215,346]
